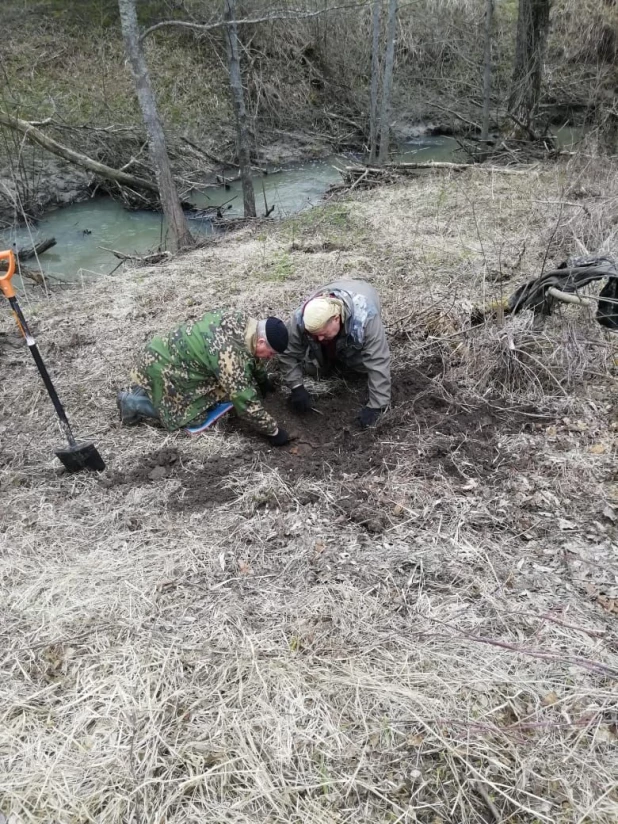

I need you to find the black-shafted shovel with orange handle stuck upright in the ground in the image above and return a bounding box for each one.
[0,249,105,472]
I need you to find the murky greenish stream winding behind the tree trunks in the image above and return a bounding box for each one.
[0,129,575,283]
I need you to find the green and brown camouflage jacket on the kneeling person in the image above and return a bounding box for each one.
[132,309,277,435]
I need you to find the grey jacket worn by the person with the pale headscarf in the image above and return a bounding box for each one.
[279,280,391,409]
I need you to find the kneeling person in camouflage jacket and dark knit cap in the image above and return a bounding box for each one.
[118,309,289,446]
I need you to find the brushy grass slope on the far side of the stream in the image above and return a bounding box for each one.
[0,0,616,162]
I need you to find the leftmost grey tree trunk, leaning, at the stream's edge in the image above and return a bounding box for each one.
[118,0,194,250]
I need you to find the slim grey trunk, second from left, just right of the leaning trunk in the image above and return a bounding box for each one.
[224,0,256,217]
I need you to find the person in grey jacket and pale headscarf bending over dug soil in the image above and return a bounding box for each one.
[279,280,391,427]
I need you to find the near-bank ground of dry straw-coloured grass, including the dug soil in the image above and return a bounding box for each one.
[0,161,618,824]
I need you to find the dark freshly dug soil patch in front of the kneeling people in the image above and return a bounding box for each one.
[111,359,541,516]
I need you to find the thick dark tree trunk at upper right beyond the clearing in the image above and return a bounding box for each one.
[508,0,552,132]
